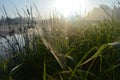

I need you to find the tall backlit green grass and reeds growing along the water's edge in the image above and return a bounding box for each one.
[0,3,120,80]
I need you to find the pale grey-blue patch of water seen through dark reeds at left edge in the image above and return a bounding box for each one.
[0,34,25,56]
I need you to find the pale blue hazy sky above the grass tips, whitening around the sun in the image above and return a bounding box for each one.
[0,0,119,17]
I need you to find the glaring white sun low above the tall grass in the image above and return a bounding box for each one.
[54,0,86,17]
